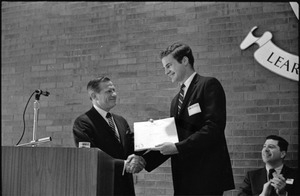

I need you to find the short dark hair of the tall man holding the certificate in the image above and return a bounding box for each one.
[160,43,194,68]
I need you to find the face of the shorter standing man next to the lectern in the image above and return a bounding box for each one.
[92,81,117,112]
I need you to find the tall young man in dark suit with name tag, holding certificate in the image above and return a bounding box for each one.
[143,43,234,195]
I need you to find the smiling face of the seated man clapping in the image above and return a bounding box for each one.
[261,139,286,167]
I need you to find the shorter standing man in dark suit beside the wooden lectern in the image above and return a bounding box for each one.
[73,77,145,195]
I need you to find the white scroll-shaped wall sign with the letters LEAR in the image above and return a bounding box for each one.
[240,26,299,81]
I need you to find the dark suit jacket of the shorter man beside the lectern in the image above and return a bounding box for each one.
[73,107,135,195]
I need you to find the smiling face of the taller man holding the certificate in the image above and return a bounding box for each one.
[161,54,187,83]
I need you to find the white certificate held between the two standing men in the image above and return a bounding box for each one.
[133,117,178,151]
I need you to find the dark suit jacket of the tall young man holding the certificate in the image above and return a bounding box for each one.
[144,74,234,195]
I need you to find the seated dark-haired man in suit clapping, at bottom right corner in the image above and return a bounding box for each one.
[238,135,300,196]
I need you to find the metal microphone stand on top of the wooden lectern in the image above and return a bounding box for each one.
[17,93,51,147]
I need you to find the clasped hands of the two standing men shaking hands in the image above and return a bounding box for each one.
[125,154,146,174]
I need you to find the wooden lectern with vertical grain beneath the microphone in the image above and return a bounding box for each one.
[2,146,114,196]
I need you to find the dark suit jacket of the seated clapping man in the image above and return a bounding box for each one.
[238,165,300,196]
